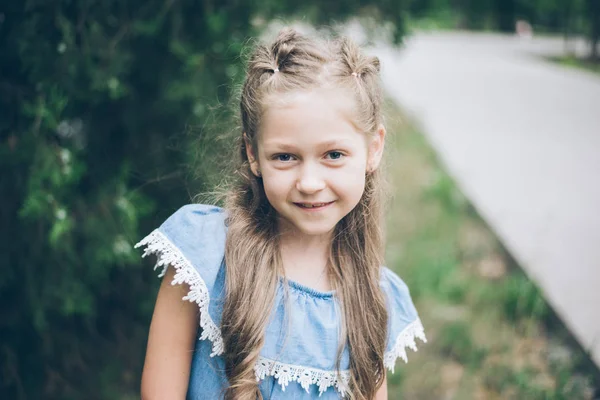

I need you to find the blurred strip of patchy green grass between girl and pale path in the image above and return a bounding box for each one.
[386,103,598,400]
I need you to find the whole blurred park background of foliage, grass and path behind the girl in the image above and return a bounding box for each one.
[0,0,600,399]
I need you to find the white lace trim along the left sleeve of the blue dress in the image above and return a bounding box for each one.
[135,229,223,357]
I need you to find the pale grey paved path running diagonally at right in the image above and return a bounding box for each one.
[374,32,600,366]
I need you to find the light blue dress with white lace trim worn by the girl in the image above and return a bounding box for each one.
[136,204,426,400]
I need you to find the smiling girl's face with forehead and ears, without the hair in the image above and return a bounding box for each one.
[247,89,385,236]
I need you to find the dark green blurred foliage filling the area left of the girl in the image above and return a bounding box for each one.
[0,0,412,399]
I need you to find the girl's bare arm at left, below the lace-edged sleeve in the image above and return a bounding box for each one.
[141,267,198,400]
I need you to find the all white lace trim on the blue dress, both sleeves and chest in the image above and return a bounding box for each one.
[135,229,427,396]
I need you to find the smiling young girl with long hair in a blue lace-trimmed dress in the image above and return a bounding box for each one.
[136,29,425,400]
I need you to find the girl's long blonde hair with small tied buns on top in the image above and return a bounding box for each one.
[221,28,388,400]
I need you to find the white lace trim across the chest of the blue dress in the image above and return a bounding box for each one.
[254,357,350,397]
